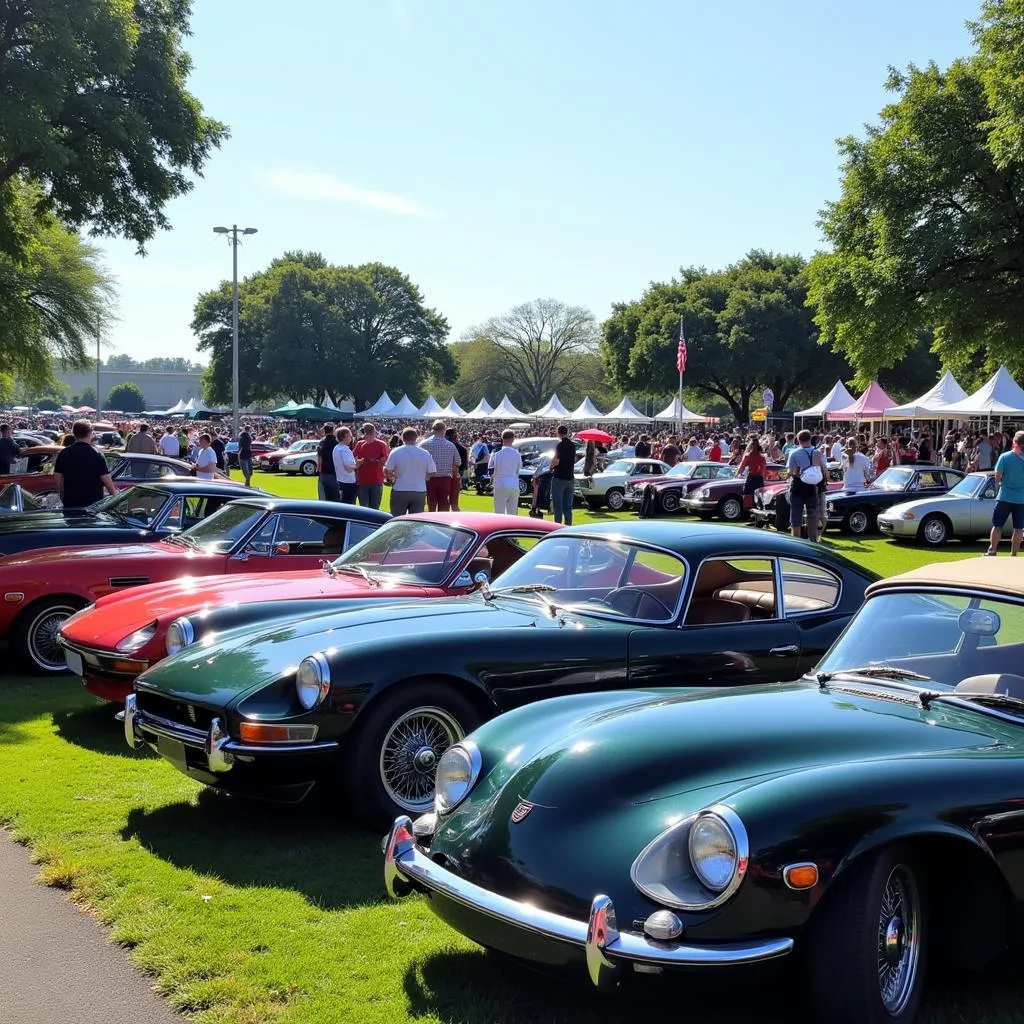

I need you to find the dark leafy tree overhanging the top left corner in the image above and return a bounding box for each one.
[0,0,227,252]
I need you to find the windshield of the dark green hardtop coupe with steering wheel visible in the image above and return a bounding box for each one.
[494,534,686,623]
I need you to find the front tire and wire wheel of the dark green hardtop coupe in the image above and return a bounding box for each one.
[345,682,481,827]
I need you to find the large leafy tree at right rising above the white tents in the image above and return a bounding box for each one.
[809,48,1024,384]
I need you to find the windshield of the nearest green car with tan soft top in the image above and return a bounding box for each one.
[815,592,1024,689]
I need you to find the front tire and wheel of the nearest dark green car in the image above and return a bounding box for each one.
[807,846,928,1024]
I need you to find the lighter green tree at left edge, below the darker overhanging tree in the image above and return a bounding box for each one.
[0,181,114,388]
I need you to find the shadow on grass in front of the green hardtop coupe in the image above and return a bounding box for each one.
[121,790,385,910]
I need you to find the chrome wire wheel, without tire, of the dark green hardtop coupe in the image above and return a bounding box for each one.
[380,708,464,812]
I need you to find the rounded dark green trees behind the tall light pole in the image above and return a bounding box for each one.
[193,253,456,408]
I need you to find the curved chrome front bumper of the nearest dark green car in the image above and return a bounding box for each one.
[384,816,794,988]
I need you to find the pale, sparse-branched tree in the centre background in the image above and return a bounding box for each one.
[466,299,600,409]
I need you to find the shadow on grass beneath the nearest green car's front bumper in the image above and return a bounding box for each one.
[403,949,808,1024]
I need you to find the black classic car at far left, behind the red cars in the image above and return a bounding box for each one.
[0,478,253,556]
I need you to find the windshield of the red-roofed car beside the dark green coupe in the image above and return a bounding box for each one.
[333,519,475,585]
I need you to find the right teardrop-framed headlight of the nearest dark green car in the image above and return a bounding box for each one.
[631,805,750,910]
